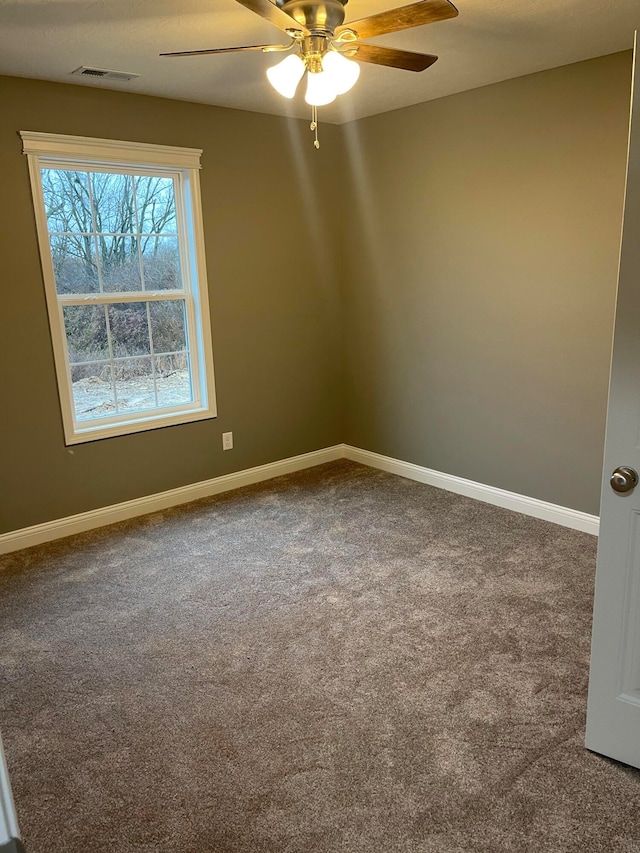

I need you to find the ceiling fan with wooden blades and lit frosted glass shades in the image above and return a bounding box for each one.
[160,0,458,148]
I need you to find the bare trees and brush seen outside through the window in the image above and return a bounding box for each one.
[42,168,186,374]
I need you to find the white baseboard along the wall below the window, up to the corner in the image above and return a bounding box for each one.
[0,444,344,554]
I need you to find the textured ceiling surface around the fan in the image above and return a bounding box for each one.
[0,0,640,124]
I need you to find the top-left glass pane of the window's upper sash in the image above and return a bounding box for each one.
[40,169,93,234]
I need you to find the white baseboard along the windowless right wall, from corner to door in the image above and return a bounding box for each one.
[343,444,600,536]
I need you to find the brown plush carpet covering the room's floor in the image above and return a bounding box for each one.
[0,462,640,853]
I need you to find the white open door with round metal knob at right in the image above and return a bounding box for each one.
[586,34,640,767]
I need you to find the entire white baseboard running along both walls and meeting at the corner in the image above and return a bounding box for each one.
[0,444,600,554]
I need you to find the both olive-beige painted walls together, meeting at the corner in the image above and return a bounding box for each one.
[0,54,630,532]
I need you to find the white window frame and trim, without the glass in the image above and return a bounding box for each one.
[20,131,217,445]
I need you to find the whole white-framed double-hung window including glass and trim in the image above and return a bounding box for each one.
[21,131,216,444]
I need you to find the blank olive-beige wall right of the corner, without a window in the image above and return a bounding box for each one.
[344,53,631,513]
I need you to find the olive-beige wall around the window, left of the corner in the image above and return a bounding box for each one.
[0,78,343,531]
